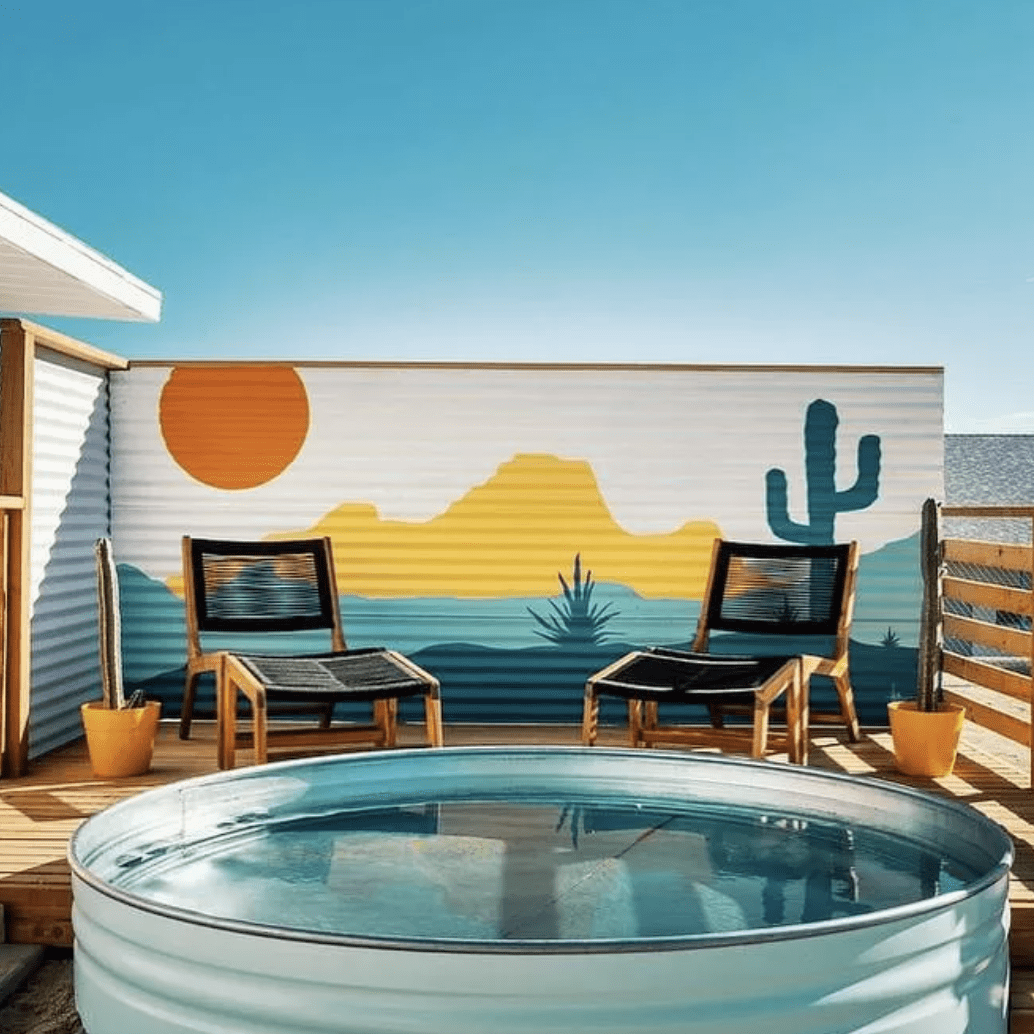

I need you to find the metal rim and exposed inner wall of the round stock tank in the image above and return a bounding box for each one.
[68,747,1013,954]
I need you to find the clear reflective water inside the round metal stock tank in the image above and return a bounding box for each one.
[110,794,980,942]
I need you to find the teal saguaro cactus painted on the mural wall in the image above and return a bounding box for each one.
[765,398,880,546]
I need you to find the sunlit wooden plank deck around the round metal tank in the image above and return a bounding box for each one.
[6,722,1034,1034]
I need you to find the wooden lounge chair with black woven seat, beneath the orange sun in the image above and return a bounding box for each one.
[180,536,443,768]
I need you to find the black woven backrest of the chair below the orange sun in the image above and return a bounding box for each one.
[190,539,336,632]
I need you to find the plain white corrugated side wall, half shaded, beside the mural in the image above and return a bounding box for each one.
[29,348,110,757]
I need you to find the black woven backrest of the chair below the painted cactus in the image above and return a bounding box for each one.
[707,542,851,636]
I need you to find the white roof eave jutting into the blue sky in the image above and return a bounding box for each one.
[0,193,161,323]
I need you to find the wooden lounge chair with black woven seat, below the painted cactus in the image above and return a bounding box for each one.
[582,539,860,764]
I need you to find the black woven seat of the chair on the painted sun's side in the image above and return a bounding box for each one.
[235,648,427,701]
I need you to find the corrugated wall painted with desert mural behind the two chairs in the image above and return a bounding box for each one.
[111,363,943,723]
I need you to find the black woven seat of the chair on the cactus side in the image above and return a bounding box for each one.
[597,648,794,703]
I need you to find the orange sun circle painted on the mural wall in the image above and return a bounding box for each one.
[158,363,309,489]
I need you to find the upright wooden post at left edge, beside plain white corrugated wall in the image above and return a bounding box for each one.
[0,320,35,777]
